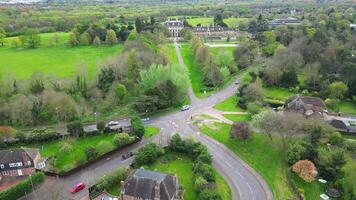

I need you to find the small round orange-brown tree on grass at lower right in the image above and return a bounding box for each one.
[292,160,318,182]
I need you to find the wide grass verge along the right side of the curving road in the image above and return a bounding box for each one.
[201,123,293,199]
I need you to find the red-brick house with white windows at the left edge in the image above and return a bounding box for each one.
[0,148,45,178]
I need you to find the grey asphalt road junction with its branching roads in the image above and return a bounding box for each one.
[29,43,273,200]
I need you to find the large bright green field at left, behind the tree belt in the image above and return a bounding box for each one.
[0,33,123,79]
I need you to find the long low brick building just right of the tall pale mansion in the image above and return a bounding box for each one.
[193,24,237,39]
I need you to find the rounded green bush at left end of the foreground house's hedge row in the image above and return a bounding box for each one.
[134,143,164,166]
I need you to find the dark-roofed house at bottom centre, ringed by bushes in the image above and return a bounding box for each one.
[121,169,182,200]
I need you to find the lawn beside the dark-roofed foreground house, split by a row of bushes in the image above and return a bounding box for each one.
[148,153,231,200]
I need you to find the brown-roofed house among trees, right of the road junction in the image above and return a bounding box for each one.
[284,95,326,116]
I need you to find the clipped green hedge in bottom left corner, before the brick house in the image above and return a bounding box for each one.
[0,172,45,200]
